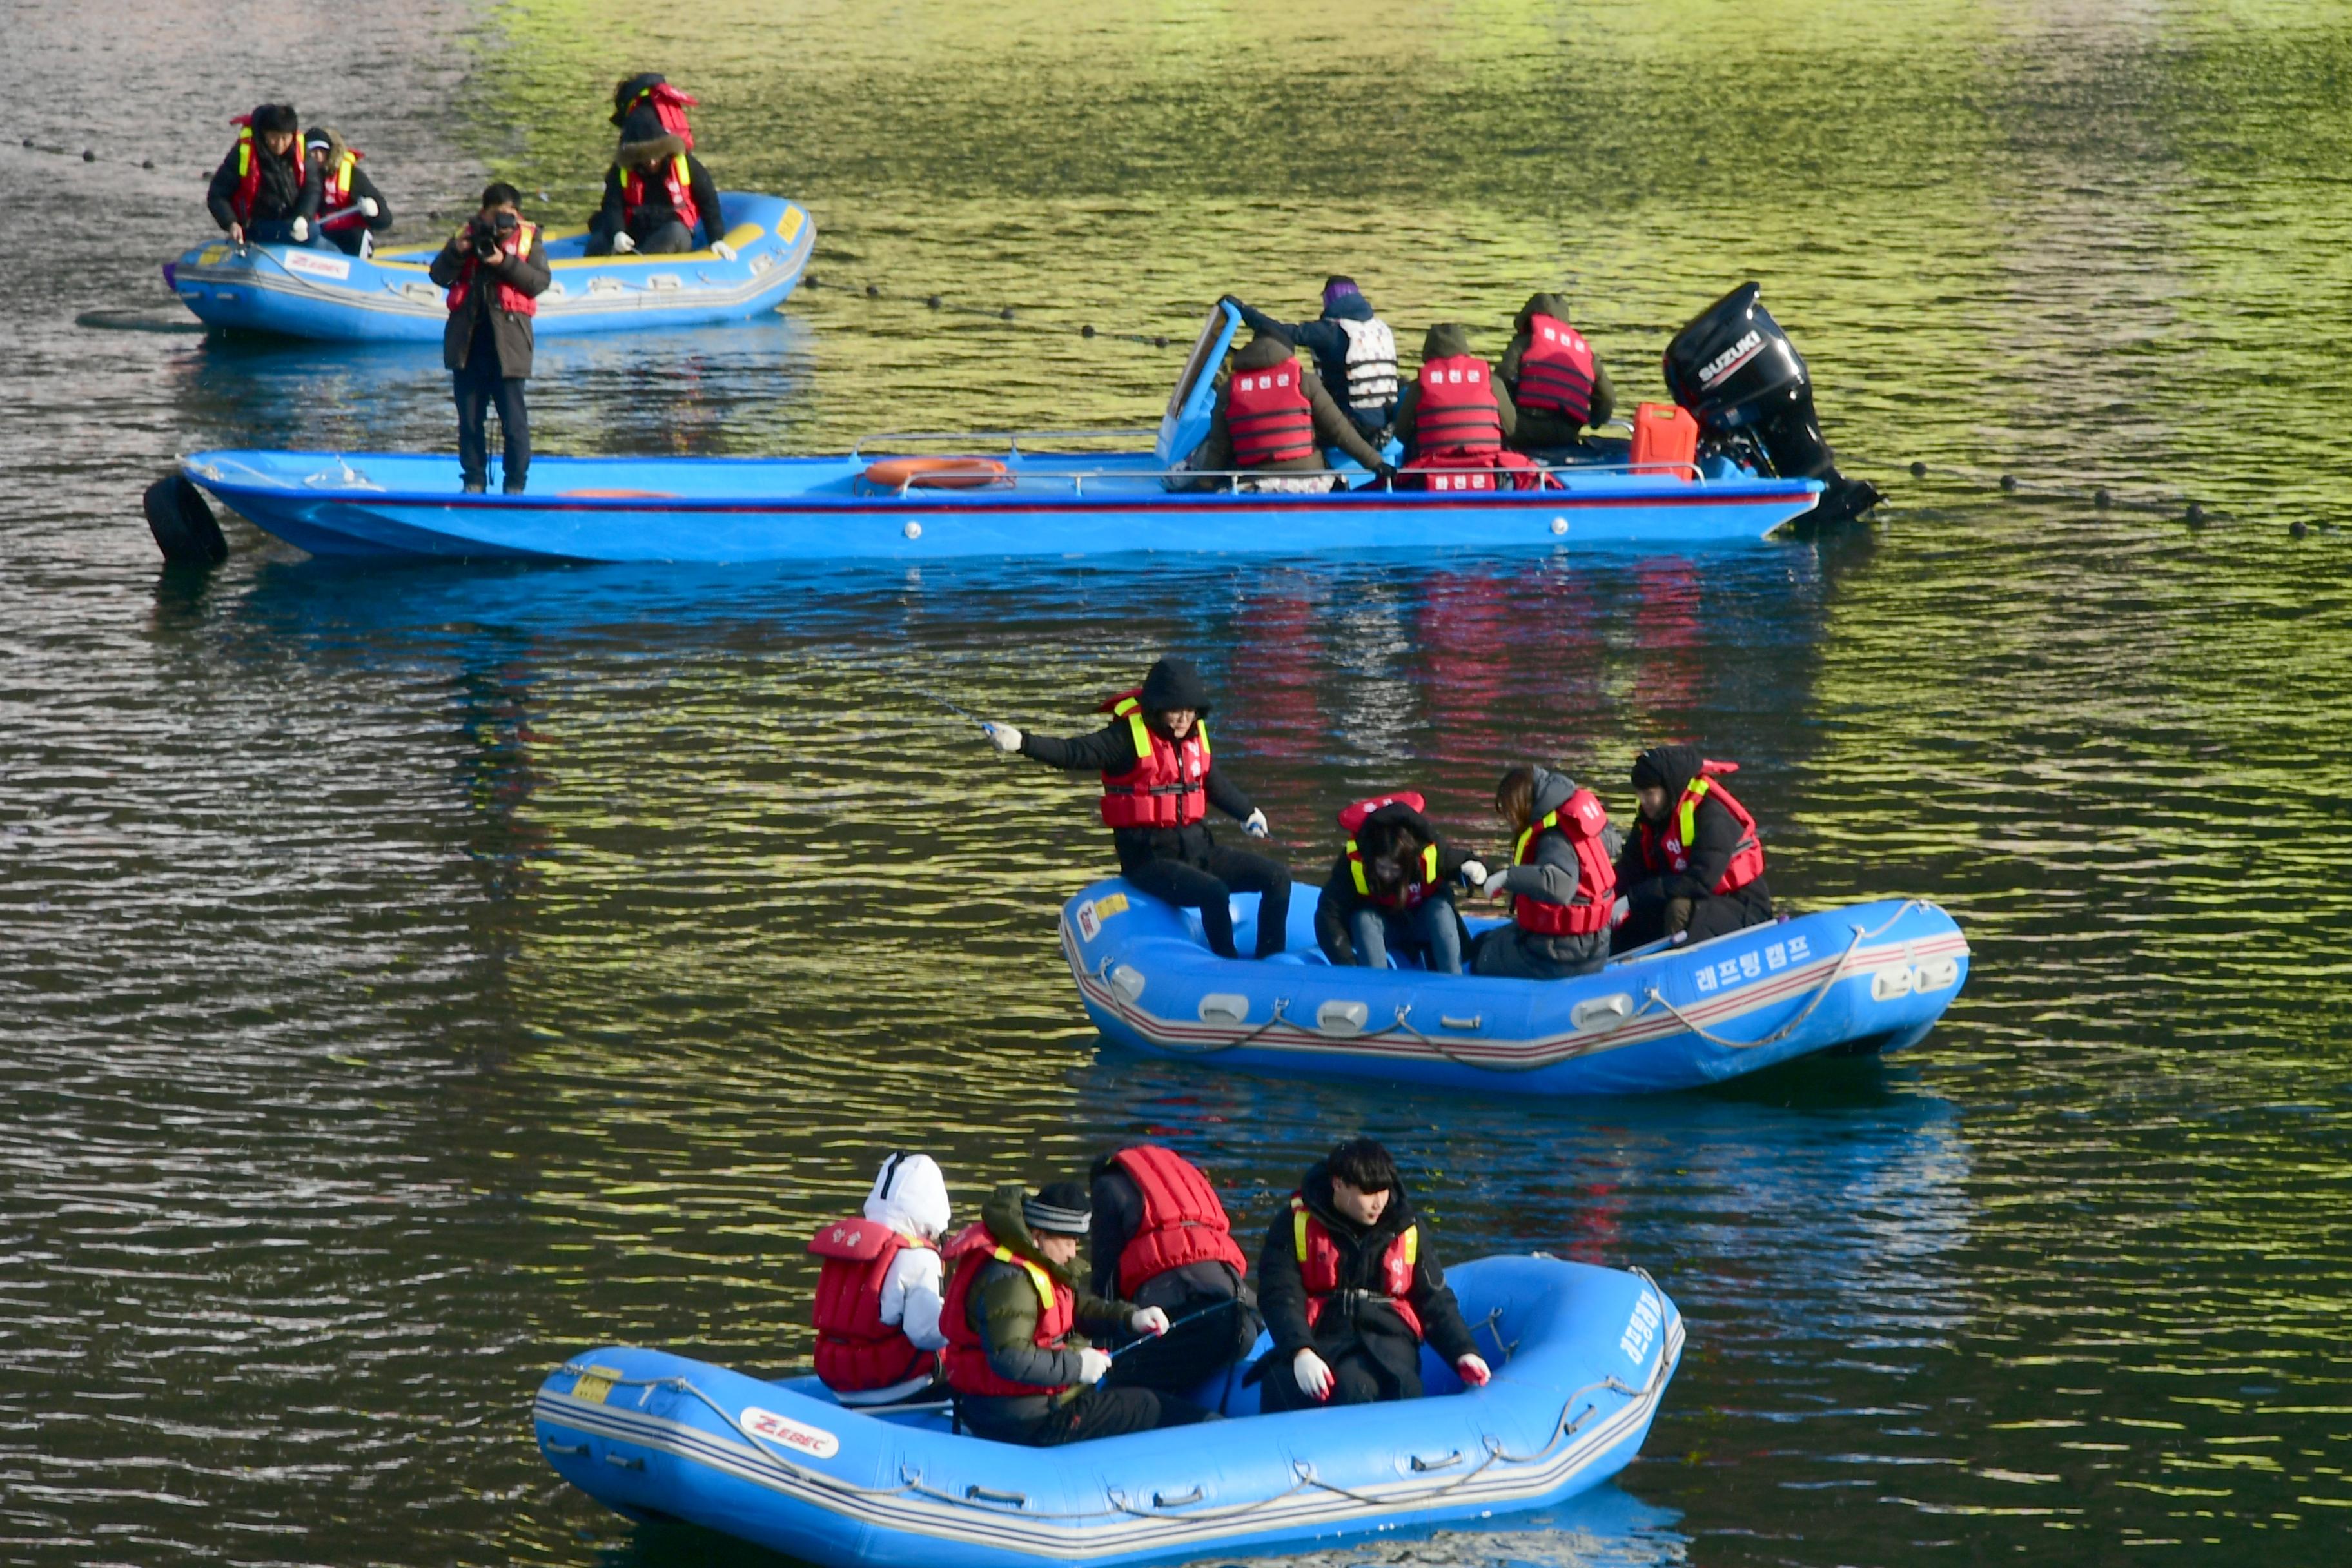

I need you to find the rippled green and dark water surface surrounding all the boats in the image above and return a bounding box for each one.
[0,0,2352,1568]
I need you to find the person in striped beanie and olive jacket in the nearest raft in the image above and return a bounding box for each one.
[941,1182,1211,1448]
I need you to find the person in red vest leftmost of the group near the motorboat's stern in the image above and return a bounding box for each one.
[1171,331,1395,494]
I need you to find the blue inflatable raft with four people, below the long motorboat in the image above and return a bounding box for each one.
[1061,879,1968,1095]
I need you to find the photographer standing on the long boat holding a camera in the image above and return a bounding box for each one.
[431,181,551,496]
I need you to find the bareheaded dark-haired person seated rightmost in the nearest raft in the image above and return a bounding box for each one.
[1259,1138,1487,1413]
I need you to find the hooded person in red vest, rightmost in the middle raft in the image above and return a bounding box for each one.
[1616,745,1771,952]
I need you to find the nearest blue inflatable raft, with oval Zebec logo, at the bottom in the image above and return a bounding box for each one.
[534,1255,1681,1568]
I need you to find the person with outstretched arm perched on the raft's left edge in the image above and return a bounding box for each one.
[981,658,1291,959]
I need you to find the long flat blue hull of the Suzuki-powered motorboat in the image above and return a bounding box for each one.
[184,451,1821,562]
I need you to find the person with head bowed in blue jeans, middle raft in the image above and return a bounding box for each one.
[1315,790,1487,975]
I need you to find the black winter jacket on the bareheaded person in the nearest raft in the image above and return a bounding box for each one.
[1259,1161,1477,1398]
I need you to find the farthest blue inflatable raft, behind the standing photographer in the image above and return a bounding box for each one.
[164,190,816,343]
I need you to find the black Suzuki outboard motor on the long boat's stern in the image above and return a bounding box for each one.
[1665,282,1879,527]
